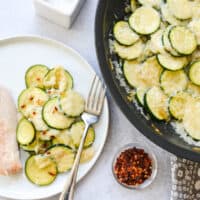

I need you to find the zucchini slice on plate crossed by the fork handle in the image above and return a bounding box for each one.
[70,121,95,148]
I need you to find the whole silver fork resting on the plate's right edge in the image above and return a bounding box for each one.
[59,75,106,200]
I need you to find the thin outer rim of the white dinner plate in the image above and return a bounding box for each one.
[0,34,110,200]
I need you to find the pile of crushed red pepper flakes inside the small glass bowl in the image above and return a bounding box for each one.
[114,147,152,186]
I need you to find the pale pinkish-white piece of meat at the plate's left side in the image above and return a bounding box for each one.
[0,86,22,175]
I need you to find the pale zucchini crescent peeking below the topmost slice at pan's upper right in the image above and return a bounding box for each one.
[161,4,188,25]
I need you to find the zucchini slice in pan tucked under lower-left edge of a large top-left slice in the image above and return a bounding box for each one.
[113,21,139,46]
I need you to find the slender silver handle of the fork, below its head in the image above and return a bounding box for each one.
[59,123,90,200]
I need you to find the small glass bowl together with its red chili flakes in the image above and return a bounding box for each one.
[113,144,157,189]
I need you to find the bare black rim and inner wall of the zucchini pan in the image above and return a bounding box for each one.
[95,0,200,162]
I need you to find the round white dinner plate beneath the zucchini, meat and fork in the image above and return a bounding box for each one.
[0,36,109,200]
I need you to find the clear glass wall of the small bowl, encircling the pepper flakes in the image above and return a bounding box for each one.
[112,143,158,190]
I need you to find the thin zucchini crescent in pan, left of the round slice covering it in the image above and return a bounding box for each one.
[162,26,180,56]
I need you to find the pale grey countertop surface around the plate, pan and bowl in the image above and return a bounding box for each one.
[0,0,171,200]
